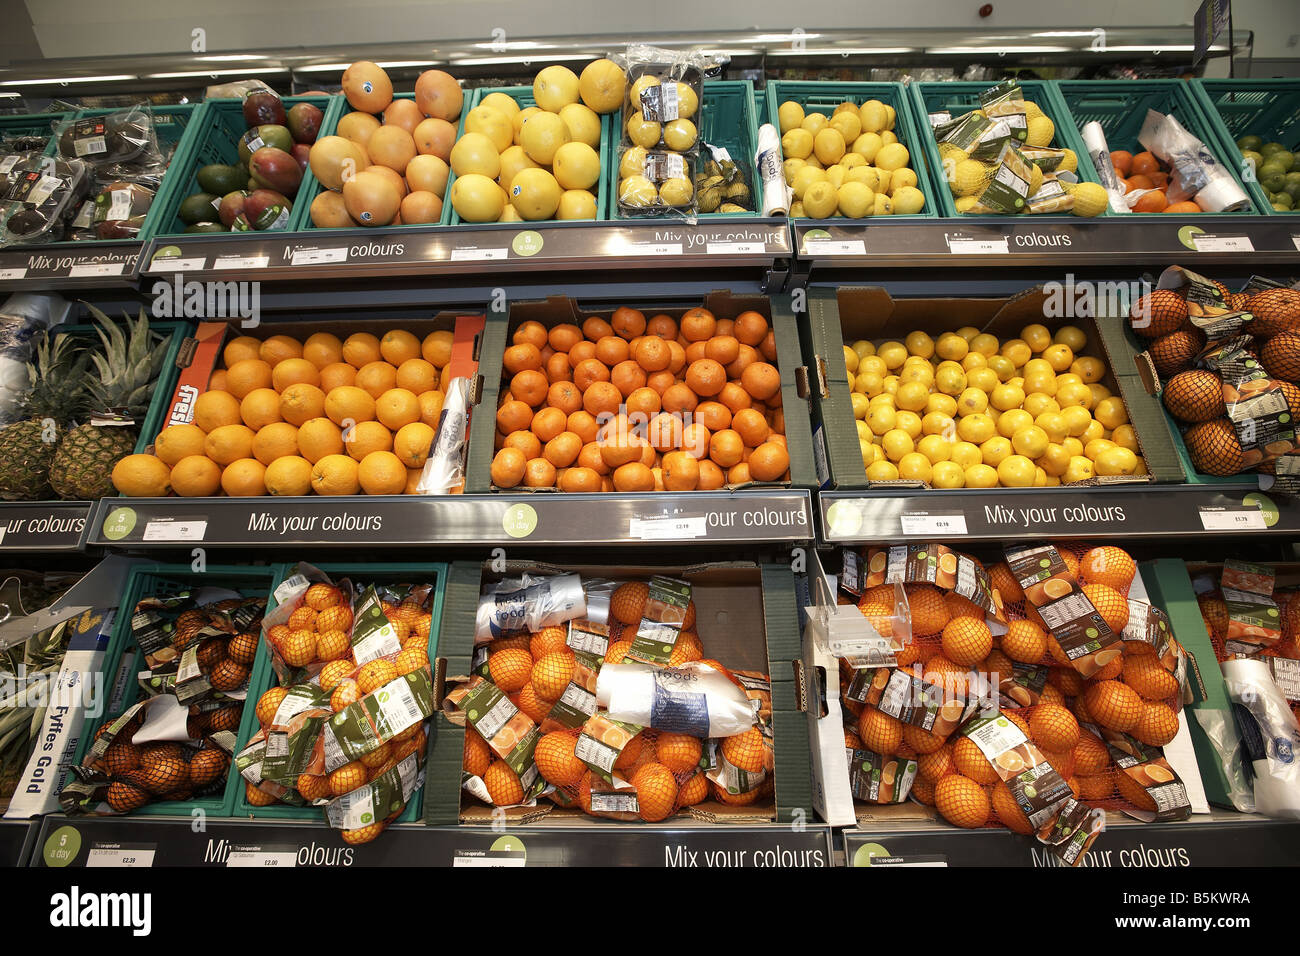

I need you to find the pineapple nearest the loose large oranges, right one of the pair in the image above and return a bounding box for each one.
[49,306,166,501]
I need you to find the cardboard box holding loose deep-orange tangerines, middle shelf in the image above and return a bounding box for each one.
[465,291,816,493]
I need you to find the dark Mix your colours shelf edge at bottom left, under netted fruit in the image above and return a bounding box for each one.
[33,816,831,868]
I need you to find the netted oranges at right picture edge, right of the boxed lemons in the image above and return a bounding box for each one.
[1130,265,1300,488]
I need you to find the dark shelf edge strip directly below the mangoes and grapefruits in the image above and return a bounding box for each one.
[142,219,790,281]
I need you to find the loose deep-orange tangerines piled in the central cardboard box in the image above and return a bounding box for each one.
[491,306,790,492]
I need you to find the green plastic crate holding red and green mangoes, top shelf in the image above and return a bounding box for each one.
[150,96,343,238]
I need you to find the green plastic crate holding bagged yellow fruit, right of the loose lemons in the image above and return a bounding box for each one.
[911,79,1108,222]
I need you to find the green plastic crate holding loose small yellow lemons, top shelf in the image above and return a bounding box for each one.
[766,79,948,221]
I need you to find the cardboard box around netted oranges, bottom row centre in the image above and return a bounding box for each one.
[424,562,813,829]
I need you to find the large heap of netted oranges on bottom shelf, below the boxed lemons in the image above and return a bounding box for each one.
[841,544,1191,861]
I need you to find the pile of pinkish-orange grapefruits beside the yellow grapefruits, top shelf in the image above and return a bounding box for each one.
[308,60,464,228]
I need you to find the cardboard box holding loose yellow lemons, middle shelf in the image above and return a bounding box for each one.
[809,286,1183,490]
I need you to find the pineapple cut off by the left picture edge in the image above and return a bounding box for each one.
[0,334,90,501]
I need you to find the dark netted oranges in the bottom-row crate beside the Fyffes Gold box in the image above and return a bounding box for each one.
[60,591,267,813]
